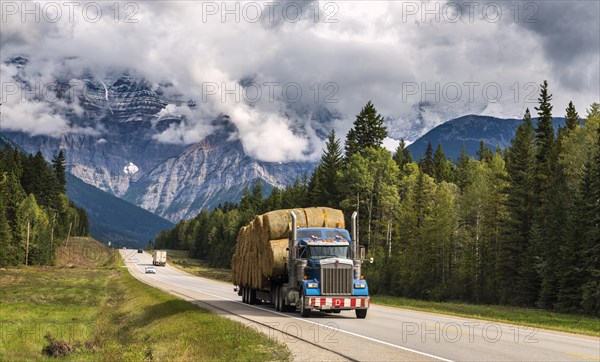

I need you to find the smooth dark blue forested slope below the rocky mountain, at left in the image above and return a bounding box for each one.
[67,174,173,247]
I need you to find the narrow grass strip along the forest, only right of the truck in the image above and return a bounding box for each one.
[371,296,600,336]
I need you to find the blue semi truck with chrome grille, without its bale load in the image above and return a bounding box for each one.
[234,210,370,319]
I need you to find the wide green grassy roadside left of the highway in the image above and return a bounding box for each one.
[0,241,290,361]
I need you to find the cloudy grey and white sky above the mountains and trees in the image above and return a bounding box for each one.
[0,0,600,161]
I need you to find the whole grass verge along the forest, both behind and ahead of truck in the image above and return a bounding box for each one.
[162,250,600,336]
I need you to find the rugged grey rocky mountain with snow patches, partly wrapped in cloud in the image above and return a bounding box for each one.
[2,58,314,221]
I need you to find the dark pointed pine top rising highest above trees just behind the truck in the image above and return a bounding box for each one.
[346,101,387,159]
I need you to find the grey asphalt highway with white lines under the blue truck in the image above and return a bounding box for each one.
[120,250,600,361]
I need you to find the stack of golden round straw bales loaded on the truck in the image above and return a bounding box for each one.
[231,207,345,289]
